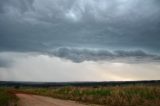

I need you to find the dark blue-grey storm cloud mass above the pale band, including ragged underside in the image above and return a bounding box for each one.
[0,0,160,62]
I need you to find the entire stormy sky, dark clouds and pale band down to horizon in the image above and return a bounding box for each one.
[0,0,160,82]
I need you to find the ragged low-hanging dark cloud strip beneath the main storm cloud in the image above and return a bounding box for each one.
[51,48,160,63]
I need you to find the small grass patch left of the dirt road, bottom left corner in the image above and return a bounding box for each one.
[0,88,18,106]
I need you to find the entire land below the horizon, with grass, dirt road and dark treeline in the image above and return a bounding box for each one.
[0,81,160,106]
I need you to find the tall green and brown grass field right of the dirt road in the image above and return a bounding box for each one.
[16,85,160,106]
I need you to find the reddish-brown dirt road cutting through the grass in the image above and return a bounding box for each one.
[16,94,90,106]
